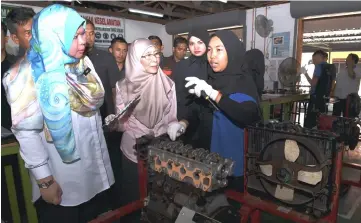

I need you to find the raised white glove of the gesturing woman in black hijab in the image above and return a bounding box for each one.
[185,77,219,101]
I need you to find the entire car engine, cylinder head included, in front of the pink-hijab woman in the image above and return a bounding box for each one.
[138,136,240,223]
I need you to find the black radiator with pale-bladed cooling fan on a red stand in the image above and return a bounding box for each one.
[226,122,342,223]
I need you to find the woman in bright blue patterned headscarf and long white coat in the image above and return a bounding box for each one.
[3,4,114,223]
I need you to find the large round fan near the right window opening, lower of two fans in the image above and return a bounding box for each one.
[278,57,301,90]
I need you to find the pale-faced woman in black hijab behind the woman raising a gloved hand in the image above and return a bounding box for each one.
[168,30,209,146]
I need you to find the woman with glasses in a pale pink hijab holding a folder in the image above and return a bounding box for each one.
[109,39,178,207]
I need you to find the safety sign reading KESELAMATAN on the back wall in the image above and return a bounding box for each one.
[79,13,125,48]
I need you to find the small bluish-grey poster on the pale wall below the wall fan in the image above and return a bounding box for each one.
[271,32,290,58]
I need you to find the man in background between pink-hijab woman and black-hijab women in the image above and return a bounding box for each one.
[163,36,188,79]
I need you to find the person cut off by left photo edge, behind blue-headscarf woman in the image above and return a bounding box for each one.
[1,22,16,129]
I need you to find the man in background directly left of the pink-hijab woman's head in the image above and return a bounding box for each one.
[109,37,128,85]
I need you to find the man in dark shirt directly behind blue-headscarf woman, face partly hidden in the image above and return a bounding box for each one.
[85,19,122,209]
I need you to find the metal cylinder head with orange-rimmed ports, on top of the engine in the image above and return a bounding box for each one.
[139,136,234,192]
